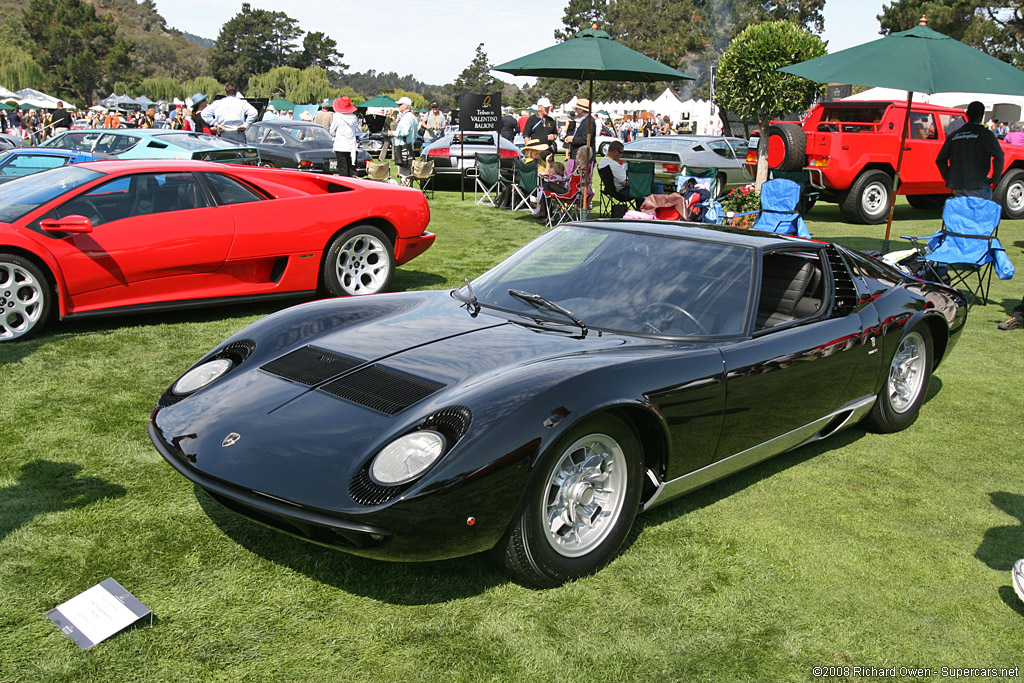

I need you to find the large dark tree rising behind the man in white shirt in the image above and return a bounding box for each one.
[210,2,302,88]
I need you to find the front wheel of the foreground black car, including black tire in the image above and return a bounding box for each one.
[495,415,643,588]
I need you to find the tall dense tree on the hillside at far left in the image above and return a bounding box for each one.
[23,0,131,104]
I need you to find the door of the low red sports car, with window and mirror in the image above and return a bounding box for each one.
[42,172,234,308]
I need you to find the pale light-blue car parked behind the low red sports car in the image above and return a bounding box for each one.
[43,128,259,166]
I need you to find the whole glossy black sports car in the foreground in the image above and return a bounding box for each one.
[150,221,967,586]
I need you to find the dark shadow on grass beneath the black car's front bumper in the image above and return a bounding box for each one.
[195,486,511,605]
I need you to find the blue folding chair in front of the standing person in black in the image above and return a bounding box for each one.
[903,197,1014,307]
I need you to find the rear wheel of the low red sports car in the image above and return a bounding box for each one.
[322,225,395,296]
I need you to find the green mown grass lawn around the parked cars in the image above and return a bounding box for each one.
[0,184,1024,683]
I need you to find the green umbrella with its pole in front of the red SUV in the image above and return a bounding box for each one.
[779,16,1024,245]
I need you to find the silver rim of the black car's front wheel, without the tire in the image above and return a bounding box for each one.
[541,434,627,557]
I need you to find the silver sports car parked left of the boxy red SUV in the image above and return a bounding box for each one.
[623,135,750,197]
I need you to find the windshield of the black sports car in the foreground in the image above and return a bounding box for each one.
[458,225,754,337]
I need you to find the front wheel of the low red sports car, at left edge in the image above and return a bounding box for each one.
[0,254,51,341]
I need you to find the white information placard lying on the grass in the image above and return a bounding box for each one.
[46,579,153,649]
